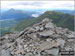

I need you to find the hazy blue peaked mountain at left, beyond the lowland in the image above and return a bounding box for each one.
[1,9,31,20]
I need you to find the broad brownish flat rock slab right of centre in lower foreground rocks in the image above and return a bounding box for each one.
[39,41,59,51]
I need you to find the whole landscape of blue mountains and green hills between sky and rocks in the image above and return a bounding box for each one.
[0,9,74,35]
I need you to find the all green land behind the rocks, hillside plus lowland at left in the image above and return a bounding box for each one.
[0,11,74,35]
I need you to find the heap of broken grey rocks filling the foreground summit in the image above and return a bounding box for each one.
[0,18,75,56]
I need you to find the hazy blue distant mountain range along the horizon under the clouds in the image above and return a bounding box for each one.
[1,9,74,20]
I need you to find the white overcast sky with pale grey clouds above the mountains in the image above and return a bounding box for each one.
[1,1,74,10]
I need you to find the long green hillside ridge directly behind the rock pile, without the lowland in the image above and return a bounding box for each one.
[14,11,74,31]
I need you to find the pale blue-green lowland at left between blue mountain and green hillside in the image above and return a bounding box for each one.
[0,17,33,36]
